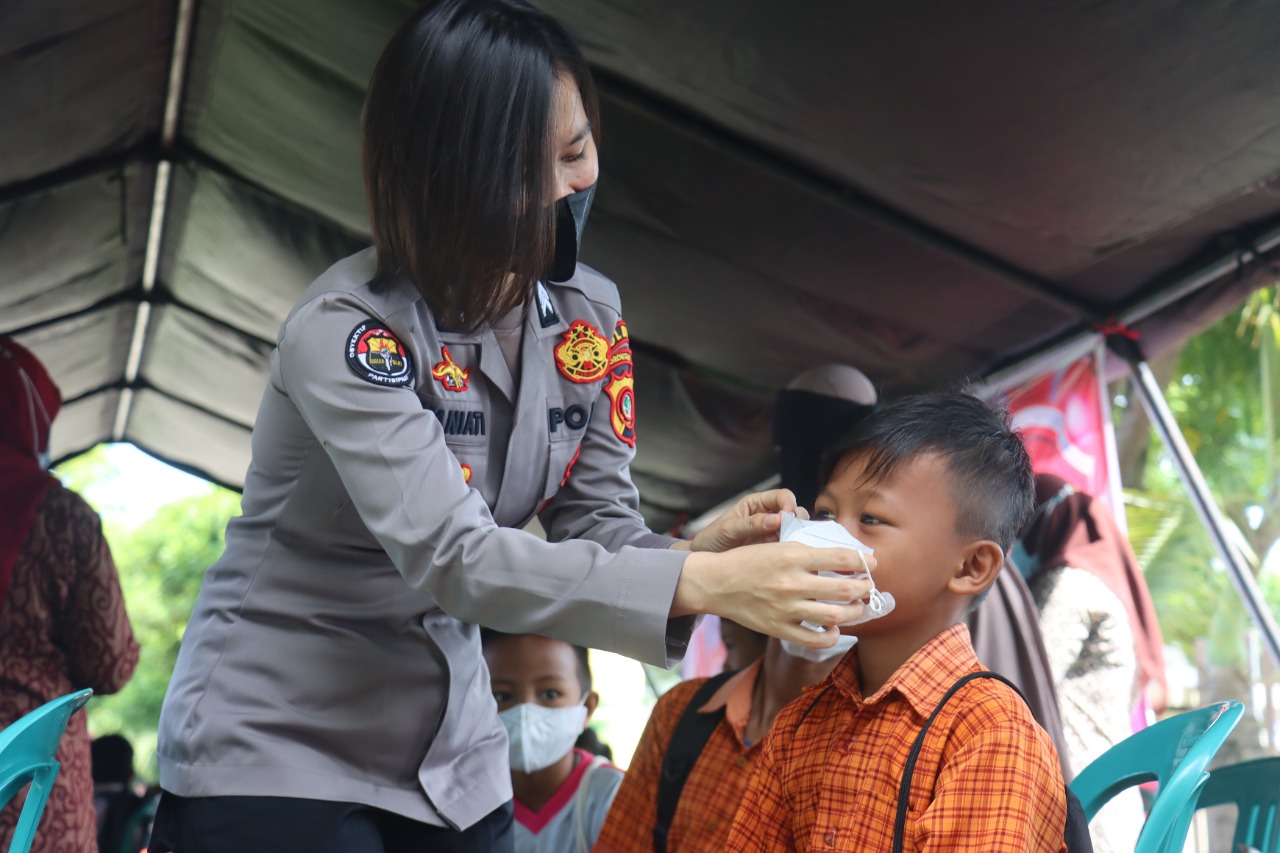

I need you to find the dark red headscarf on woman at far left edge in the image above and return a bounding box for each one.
[0,337,63,605]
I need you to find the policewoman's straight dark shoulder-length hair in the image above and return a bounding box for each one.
[362,0,599,333]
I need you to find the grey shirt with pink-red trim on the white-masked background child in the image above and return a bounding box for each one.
[515,749,622,853]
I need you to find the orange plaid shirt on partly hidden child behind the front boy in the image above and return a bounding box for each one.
[593,661,760,853]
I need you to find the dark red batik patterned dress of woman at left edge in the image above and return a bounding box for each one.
[0,485,138,853]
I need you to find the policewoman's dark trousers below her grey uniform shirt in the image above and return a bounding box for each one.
[148,792,515,853]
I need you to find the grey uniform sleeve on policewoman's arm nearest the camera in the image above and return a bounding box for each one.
[278,293,691,666]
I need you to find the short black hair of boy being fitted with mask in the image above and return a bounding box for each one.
[822,393,1036,552]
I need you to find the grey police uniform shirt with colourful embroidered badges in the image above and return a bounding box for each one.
[157,250,692,827]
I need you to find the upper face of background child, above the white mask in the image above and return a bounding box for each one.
[484,634,596,716]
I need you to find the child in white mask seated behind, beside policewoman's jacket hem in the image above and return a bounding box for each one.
[480,630,622,853]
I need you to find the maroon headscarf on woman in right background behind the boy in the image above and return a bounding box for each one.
[1023,474,1166,711]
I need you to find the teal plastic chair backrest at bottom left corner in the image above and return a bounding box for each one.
[0,690,93,853]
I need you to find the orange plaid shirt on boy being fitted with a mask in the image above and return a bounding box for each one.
[727,624,1066,853]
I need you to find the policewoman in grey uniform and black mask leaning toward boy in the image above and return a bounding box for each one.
[151,0,868,853]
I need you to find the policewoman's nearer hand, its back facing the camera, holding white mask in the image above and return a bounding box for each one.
[671,542,876,648]
